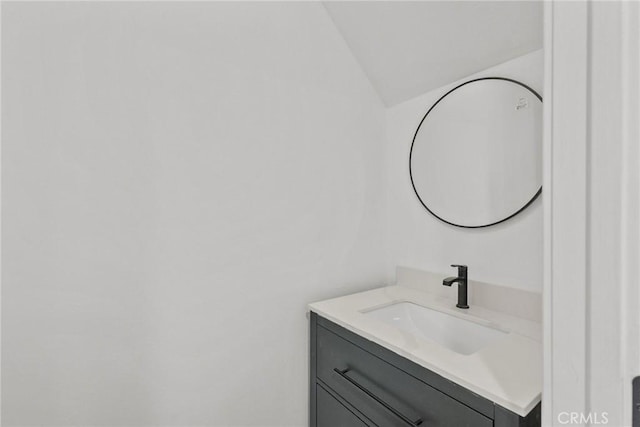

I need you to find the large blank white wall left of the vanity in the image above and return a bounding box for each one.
[2,2,384,426]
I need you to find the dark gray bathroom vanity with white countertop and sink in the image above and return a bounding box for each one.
[309,270,542,427]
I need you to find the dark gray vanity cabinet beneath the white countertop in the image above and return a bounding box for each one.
[310,312,540,427]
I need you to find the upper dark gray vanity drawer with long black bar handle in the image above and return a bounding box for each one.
[315,325,493,427]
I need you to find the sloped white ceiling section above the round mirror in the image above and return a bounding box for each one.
[324,1,542,106]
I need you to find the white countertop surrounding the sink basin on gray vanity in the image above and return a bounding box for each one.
[309,286,542,416]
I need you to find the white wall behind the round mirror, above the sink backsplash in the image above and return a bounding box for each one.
[387,50,543,292]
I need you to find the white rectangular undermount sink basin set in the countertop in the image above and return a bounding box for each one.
[363,302,508,355]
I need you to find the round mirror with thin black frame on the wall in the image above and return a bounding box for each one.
[409,77,542,228]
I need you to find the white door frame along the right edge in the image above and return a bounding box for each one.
[542,1,640,427]
